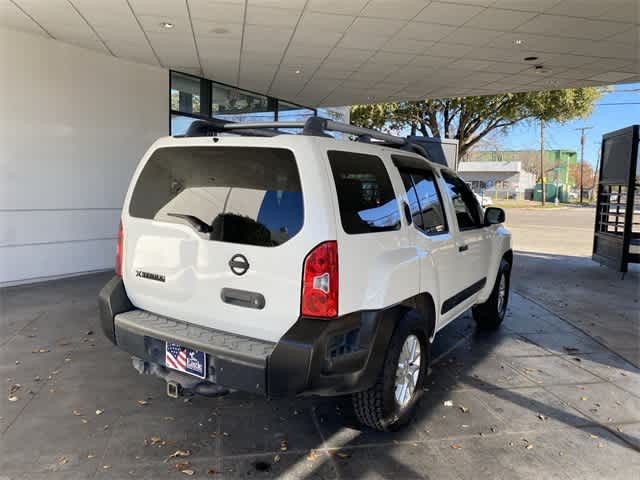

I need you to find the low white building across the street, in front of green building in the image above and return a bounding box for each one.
[458,161,536,199]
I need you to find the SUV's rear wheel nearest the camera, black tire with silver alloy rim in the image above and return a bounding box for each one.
[352,310,431,431]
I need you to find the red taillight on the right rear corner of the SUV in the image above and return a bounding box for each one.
[300,241,338,318]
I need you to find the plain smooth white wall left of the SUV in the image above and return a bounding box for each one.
[0,28,169,286]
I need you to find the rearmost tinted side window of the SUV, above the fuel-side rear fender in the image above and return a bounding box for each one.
[328,151,400,234]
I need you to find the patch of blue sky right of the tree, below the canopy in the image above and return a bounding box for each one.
[498,83,640,166]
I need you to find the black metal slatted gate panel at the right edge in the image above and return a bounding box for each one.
[592,125,640,272]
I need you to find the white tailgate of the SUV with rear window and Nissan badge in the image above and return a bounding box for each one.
[123,137,335,341]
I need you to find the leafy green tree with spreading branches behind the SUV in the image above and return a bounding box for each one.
[351,87,602,157]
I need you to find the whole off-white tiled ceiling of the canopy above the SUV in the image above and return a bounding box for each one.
[0,0,640,105]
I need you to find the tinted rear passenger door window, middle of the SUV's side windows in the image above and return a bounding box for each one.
[402,171,447,235]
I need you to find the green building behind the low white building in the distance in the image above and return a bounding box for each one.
[464,149,579,190]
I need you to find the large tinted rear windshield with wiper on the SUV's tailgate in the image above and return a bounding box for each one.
[129,147,304,247]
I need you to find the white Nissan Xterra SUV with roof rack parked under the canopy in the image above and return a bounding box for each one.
[100,117,512,430]
